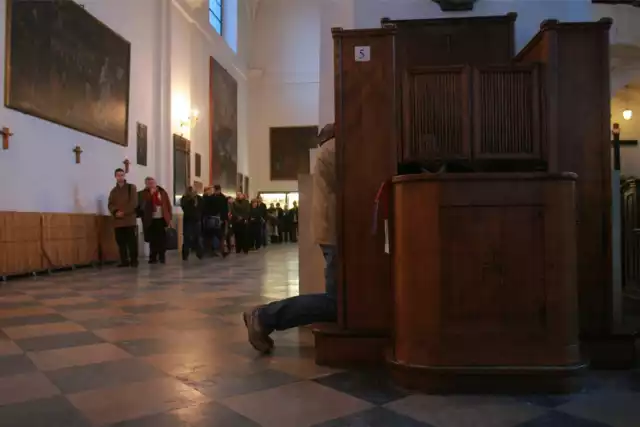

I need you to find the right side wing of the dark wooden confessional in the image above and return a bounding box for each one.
[515,19,612,337]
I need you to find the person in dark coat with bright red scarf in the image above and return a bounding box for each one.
[141,177,173,264]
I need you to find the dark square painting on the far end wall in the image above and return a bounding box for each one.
[269,126,318,181]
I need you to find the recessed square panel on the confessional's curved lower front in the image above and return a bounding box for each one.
[440,206,547,336]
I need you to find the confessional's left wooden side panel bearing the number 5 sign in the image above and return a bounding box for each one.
[333,29,397,332]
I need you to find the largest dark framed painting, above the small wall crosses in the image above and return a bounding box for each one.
[5,0,131,146]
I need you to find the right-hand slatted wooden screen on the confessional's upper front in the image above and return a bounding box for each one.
[473,66,541,159]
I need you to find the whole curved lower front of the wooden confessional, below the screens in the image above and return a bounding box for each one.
[393,173,581,392]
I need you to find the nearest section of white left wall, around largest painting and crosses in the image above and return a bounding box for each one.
[0,0,158,213]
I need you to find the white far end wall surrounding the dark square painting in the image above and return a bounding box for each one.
[249,0,321,194]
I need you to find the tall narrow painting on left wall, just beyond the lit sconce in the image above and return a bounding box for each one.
[209,58,238,192]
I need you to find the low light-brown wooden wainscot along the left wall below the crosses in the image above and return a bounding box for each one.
[0,212,124,276]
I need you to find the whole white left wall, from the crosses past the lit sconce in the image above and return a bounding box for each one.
[0,0,249,213]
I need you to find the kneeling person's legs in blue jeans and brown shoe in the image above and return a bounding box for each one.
[243,245,338,352]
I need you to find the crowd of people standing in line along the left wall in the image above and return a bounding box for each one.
[108,169,298,267]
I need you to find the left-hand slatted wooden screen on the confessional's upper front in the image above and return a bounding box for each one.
[403,67,471,161]
